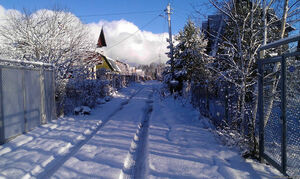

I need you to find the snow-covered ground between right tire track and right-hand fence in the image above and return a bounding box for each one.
[148,85,281,178]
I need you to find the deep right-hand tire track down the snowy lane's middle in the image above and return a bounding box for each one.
[119,91,153,179]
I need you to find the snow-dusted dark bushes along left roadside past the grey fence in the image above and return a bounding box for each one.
[56,74,136,115]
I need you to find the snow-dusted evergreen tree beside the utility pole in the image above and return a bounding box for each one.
[167,19,208,93]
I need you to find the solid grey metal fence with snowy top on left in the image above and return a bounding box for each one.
[0,60,56,144]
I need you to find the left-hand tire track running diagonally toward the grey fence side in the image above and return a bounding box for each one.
[34,87,143,179]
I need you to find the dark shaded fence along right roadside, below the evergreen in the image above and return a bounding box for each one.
[191,81,238,127]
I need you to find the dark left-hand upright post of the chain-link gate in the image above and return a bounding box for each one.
[257,51,265,162]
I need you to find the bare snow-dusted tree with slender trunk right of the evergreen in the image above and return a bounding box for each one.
[210,0,262,131]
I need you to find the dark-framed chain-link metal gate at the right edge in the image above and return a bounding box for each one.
[258,35,300,178]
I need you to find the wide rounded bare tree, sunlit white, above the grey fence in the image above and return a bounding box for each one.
[0,9,92,79]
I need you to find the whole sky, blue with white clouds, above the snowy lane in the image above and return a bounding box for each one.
[0,0,214,64]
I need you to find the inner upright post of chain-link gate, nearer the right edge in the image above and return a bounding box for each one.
[281,55,287,175]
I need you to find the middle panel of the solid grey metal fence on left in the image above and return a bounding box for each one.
[24,70,41,131]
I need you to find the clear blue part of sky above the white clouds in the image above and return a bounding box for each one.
[0,0,211,33]
